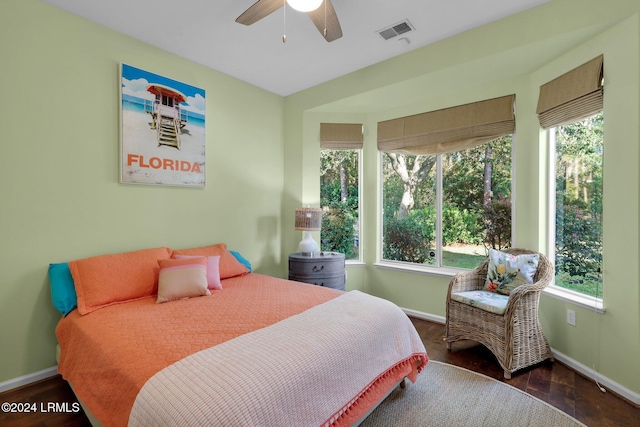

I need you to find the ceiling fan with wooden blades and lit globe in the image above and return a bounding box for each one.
[236,0,342,42]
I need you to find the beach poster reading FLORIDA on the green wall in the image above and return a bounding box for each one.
[120,64,205,187]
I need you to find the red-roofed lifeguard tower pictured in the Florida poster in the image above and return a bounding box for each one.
[147,83,187,149]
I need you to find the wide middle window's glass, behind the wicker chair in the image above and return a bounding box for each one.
[381,135,512,269]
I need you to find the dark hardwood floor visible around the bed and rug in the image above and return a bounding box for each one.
[0,318,640,427]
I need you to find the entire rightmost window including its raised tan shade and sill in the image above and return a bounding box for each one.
[536,55,604,304]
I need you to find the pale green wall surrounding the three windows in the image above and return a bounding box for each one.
[283,0,640,402]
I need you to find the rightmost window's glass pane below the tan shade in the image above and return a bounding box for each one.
[549,113,604,298]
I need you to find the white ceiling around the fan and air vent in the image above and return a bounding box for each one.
[42,0,550,96]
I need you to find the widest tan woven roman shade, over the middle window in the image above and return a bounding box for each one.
[378,95,516,155]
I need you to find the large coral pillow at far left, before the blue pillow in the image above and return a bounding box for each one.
[69,248,171,314]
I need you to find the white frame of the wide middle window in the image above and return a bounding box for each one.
[374,132,517,278]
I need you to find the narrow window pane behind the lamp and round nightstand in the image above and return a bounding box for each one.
[320,150,362,260]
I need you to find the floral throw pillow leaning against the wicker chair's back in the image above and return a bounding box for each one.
[484,249,540,295]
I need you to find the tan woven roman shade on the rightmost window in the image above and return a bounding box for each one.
[536,55,603,129]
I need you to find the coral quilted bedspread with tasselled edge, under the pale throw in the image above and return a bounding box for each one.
[56,273,427,426]
